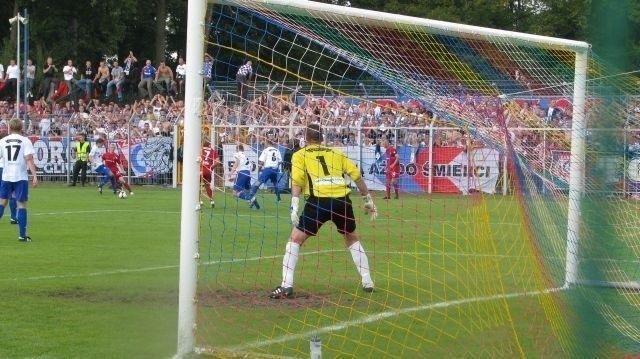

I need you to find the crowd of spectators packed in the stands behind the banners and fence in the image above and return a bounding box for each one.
[0,52,640,179]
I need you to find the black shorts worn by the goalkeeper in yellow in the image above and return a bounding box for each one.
[297,195,356,236]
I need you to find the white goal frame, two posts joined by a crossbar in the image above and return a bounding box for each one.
[176,0,590,358]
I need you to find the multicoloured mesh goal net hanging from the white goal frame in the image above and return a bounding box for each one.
[185,0,640,357]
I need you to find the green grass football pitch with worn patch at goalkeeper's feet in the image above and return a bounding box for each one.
[0,184,636,358]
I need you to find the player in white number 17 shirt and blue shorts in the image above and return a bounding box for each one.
[0,118,38,242]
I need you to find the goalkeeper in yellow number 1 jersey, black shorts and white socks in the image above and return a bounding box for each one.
[269,124,378,299]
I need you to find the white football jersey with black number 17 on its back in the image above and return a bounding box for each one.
[0,133,34,182]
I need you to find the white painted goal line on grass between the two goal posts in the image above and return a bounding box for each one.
[223,287,567,351]
